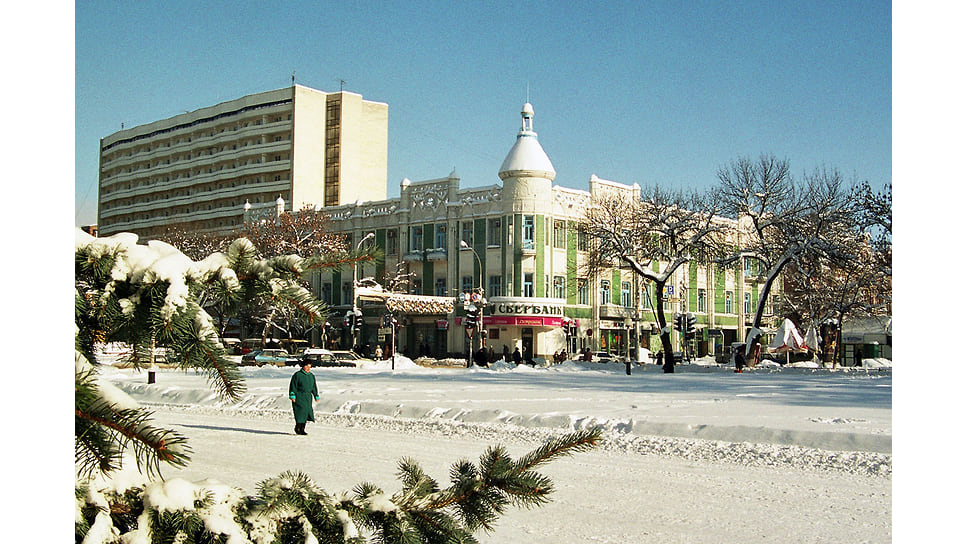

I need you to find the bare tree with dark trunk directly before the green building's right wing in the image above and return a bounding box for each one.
[581,186,725,372]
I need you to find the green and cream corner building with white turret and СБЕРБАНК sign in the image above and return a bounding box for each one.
[314,104,772,360]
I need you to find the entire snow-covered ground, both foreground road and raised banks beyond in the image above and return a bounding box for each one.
[102,359,892,544]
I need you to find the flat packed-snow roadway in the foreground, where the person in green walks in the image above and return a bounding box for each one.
[149,409,891,544]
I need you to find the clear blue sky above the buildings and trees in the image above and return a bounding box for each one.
[74,1,892,225]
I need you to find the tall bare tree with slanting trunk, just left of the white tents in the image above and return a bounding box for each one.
[718,155,857,346]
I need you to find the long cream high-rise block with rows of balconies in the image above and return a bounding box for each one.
[98,85,388,237]
